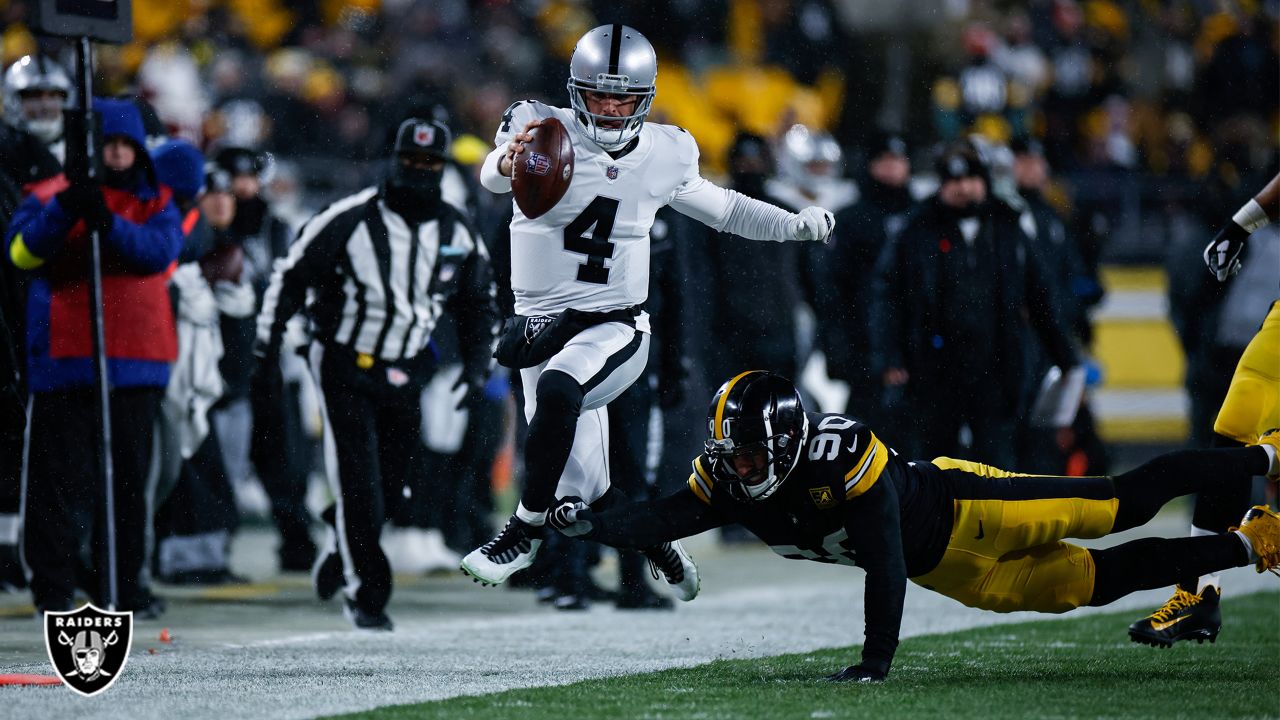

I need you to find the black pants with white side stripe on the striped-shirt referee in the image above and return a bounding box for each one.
[311,343,430,612]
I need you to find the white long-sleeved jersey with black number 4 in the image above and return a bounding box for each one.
[481,100,794,320]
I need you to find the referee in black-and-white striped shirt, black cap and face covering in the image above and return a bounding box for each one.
[255,119,497,630]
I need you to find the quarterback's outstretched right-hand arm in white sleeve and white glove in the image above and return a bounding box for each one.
[671,177,836,242]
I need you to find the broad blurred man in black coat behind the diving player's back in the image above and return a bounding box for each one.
[870,141,1075,466]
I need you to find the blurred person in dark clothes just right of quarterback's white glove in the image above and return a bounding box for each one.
[810,132,913,425]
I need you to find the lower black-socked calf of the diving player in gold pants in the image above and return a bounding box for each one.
[1089,533,1249,606]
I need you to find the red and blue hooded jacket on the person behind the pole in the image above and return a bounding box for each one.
[8,100,182,392]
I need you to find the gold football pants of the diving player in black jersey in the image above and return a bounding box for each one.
[911,457,1119,612]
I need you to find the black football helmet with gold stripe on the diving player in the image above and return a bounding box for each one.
[705,370,809,502]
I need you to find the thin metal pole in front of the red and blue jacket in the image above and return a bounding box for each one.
[72,36,119,610]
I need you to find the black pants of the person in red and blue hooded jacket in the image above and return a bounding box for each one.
[23,388,164,610]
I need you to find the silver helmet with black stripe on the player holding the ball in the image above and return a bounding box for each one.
[568,23,658,150]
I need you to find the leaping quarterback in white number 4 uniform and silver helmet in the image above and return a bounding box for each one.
[462,24,835,591]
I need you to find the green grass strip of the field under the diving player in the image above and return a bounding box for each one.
[332,592,1280,720]
